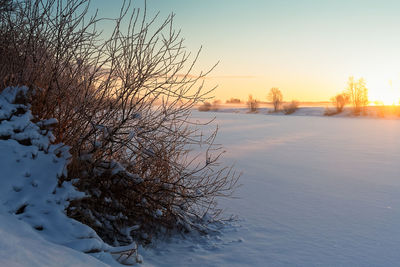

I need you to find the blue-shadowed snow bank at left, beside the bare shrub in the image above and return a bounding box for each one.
[0,87,139,266]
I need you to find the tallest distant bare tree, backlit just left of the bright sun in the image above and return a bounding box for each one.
[346,76,368,115]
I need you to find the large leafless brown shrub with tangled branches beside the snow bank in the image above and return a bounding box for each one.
[0,0,238,247]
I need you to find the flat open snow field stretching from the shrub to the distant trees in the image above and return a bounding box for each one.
[142,112,400,266]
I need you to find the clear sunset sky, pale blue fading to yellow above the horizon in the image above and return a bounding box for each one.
[92,0,400,104]
